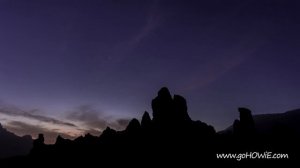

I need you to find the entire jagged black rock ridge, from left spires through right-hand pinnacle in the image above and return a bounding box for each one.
[3,88,300,167]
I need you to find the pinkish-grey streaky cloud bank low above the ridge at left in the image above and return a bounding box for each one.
[0,103,129,143]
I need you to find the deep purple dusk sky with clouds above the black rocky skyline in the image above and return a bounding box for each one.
[0,0,300,143]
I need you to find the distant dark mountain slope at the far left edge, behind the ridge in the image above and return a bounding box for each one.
[0,123,32,159]
